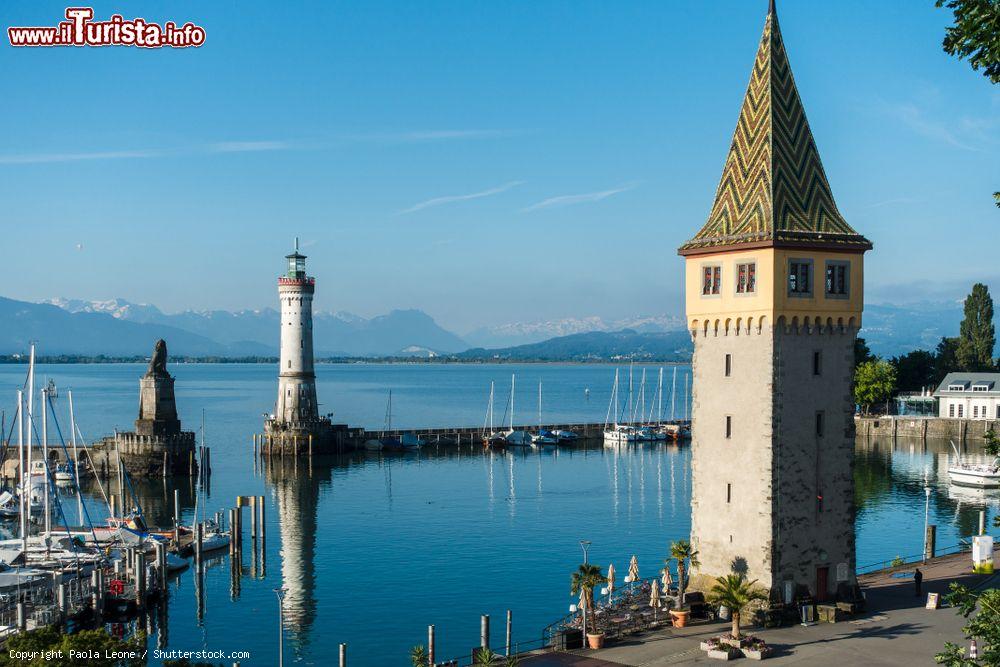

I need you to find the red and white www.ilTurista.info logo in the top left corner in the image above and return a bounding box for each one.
[7,7,205,49]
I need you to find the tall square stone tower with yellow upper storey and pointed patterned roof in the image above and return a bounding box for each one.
[678,0,872,600]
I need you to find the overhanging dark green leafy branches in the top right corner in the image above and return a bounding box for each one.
[936,0,1000,83]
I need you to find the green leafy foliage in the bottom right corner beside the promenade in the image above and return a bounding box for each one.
[934,583,1000,667]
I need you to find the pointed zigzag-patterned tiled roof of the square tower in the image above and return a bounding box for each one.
[680,1,871,254]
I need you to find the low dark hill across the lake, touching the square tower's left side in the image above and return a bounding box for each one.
[463,315,684,347]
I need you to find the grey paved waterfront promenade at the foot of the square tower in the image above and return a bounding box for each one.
[523,553,1000,667]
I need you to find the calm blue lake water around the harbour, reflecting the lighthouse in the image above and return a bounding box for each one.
[0,364,997,665]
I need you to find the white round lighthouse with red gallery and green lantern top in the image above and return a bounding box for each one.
[274,239,319,424]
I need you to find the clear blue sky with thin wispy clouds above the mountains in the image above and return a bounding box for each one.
[0,0,1000,332]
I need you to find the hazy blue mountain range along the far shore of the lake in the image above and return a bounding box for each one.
[0,297,976,361]
